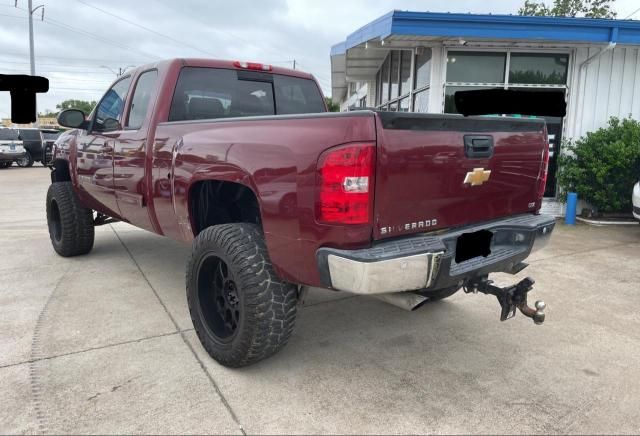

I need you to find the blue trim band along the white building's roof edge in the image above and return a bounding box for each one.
[331,11,640,56]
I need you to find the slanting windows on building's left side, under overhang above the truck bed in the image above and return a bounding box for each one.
[375,48,431,112]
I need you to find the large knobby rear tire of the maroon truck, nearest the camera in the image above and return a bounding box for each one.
[186,223,298,368]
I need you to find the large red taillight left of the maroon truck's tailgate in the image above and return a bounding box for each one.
[316,144,376,224]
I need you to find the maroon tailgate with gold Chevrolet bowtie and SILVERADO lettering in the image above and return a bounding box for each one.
[373,112,548,239]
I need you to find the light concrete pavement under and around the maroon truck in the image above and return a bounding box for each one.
[0,164,640,434]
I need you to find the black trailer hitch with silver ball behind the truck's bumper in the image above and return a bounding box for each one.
[464,276,547,325]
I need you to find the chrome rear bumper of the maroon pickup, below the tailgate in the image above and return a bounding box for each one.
[317,215,555,294]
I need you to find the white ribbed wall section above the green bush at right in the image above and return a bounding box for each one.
[565,46,640,138]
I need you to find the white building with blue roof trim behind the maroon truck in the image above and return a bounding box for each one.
[331,11,640,215]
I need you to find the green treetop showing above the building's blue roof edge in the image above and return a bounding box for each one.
[518,0,617,18]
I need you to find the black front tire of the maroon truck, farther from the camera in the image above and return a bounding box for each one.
[47,182,95,257]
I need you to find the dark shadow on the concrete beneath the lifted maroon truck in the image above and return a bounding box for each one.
[106,231,533,373]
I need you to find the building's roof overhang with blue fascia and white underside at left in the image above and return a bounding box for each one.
[331,11,640,100]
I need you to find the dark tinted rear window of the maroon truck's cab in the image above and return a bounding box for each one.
[169,67,325,121]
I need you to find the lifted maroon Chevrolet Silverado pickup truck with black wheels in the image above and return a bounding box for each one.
[46,59,555,367]
